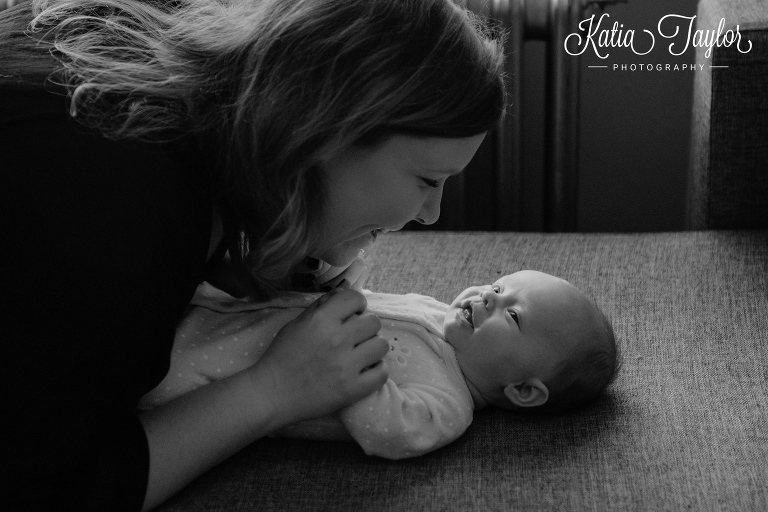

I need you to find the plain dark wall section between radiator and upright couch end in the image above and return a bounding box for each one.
[578,0,700,231]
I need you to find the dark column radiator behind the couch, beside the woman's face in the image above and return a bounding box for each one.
[415,0,626,231]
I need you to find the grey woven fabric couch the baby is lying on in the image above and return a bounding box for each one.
[154,0,768,512]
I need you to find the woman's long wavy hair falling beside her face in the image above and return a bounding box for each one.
[21,0,505,291]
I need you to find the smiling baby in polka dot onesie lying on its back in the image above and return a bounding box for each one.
[140,270,618,459]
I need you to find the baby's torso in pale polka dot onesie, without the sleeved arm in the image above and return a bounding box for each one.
[139,285,465,409]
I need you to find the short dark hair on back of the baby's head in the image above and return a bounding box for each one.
[526,299,622,414]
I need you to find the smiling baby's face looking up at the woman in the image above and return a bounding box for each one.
[443,270,598,404]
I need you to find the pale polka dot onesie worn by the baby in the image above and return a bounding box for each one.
[140,283,474,459]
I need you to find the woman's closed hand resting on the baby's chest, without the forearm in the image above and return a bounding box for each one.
[248,289,389,424]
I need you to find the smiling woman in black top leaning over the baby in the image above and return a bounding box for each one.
[0,0,504,510]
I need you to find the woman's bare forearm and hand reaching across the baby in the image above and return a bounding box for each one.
[140,290,389,509]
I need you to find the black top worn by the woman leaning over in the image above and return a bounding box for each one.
[0,70,222,511]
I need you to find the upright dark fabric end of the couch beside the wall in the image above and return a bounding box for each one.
[687,0,768,229]
